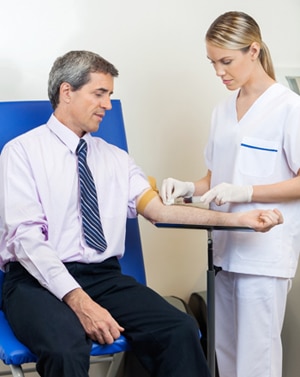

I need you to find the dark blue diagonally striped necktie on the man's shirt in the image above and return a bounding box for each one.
[76,139,107,252]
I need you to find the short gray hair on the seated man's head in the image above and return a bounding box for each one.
[48,51,119,110]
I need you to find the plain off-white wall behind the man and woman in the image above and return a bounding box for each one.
[0,0,300,377]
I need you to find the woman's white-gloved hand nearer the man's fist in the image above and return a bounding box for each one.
[201,183,253,206]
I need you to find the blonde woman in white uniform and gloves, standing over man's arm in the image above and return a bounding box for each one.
[161,12,300,377]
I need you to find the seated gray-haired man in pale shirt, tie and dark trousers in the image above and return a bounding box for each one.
[0,51,283,377]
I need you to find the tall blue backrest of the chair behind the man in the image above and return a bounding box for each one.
[0,99,146,307]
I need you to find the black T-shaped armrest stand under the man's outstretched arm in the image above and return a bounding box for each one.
[155,223,254,377]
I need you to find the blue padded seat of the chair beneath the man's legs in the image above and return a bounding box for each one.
[0,311,130,365]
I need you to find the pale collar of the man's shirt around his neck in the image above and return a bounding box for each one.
[47,114,91,153]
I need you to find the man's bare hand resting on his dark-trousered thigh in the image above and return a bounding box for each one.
[63,288,124,344]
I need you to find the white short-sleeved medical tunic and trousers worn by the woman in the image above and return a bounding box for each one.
[205,83,300,377]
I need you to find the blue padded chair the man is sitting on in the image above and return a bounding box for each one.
[0,100,146,377]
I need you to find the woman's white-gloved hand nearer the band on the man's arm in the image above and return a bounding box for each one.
[160,178,195,205]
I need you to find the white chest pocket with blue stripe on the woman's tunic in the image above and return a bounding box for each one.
[239,137,279,177]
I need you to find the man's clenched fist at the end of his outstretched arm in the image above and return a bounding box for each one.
[235,209,283,232]
